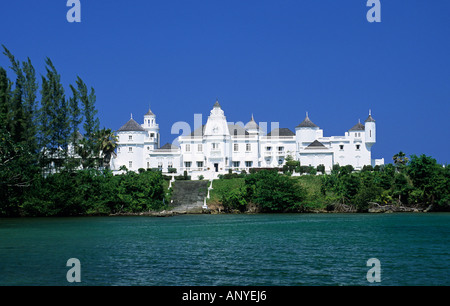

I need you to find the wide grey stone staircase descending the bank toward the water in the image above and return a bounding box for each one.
[171,181,209,213]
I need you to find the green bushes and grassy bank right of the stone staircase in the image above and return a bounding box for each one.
[210,152,450,212]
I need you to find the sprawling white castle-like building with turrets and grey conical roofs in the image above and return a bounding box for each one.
[111,101,384,179]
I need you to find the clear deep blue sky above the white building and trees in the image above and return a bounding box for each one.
[0,0,450,163]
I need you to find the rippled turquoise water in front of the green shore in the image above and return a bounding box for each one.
[0,213,450,286]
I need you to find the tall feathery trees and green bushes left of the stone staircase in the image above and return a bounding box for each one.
[0,46,165,217]
